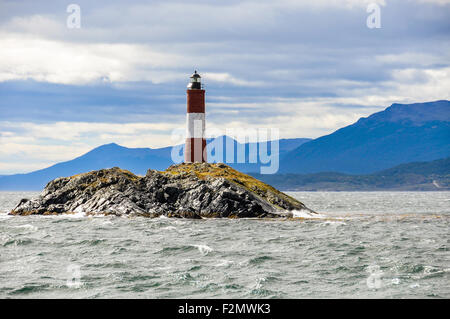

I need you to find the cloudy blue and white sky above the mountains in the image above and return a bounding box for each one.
[0,0,450,175]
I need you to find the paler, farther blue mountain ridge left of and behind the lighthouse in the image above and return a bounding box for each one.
[0,136,310,190]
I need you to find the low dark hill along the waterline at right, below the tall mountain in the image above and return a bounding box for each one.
[251,157,450,191]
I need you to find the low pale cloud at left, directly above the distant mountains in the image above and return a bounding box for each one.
[0,121,184,174]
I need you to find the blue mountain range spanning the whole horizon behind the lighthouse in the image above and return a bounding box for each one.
[0,100,450,190]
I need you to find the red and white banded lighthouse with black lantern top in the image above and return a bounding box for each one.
[184,71,206,163]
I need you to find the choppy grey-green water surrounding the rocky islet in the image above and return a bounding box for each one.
[0,192,450,298]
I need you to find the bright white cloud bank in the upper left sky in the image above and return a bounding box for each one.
[0,33,186,84]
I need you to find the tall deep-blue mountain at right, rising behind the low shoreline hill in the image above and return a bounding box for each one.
[280,101,450,174]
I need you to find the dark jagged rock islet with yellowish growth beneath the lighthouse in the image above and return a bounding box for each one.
[10,163,314,218]
